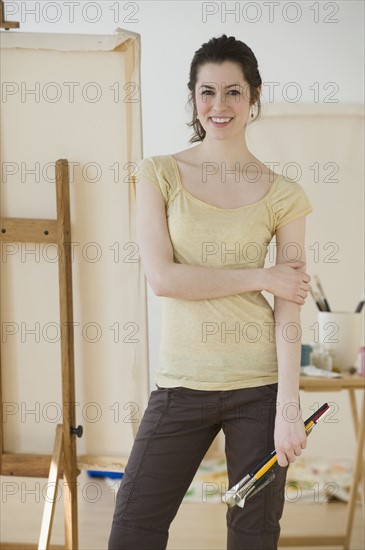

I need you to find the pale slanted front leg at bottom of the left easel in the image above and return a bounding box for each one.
[38,424,63,550]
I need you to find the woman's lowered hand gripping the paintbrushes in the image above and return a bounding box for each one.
[274,400,307,467]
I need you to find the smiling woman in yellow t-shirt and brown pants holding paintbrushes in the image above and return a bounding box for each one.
[109,35,312,550]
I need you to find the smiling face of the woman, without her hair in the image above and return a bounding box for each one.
[195,61,250,138]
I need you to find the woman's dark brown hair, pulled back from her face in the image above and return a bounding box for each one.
[187,34,262,143]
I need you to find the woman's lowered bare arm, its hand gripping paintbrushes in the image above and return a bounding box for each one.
[274,216,308,466]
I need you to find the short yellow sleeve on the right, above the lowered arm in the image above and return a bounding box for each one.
[270,176,313,232]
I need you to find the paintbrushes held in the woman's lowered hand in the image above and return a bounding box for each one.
[222,403,330,508]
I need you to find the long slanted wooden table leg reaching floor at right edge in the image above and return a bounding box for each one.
[345,394,365,549]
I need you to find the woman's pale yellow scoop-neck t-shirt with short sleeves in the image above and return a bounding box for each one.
[133,155,313,390]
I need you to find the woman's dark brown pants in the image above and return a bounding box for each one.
[108,384,288,550]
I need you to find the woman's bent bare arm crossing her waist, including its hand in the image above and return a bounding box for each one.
[136,177,311,305]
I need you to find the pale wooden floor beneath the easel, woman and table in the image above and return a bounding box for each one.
[0,472,365,550]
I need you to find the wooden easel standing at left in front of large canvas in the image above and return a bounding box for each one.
[0,159,82,550]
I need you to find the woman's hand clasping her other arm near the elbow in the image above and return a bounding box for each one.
[264,261,311,305]
